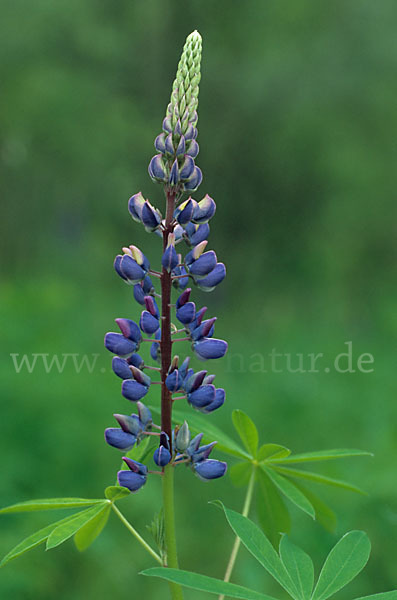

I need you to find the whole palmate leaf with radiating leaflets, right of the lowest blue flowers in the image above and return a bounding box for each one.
[210,410,371,547]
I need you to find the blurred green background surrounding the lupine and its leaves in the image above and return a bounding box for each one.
[0,0,397,600]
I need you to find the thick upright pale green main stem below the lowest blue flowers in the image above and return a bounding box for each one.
[162,465,183,600]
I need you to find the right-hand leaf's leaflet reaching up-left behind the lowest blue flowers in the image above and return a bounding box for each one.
[150,406,251,459]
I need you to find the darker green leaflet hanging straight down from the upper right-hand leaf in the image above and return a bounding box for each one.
[256,469,291,548]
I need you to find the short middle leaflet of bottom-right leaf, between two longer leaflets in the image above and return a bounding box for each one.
[279,535,314,600]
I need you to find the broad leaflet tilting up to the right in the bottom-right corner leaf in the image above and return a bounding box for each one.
[313,531,371,600]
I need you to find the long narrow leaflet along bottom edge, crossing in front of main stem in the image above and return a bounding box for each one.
[141,567,275,600]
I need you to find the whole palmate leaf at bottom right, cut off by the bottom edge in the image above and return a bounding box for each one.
[143,502,397,600]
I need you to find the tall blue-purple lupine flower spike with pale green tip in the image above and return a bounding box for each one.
[105,32,227,492]
